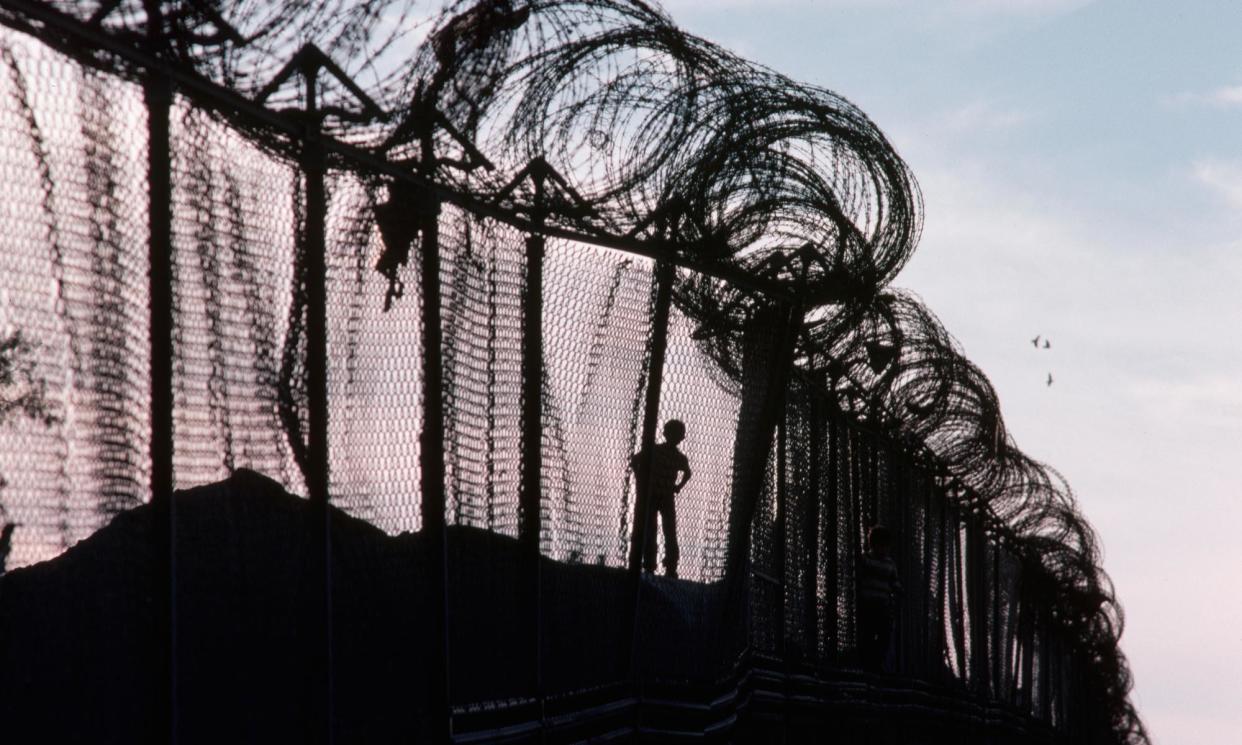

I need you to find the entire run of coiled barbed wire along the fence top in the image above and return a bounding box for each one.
[0,0,1145,743]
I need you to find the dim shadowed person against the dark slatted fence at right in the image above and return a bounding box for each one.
[857,525,902,673]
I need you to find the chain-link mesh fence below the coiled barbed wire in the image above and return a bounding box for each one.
[0,2,1137,741]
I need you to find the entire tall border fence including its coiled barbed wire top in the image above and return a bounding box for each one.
[0,0,1146,743]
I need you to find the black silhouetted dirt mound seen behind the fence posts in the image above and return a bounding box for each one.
[0,471,744,744]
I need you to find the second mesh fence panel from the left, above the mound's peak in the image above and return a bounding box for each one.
[171,102,306,493]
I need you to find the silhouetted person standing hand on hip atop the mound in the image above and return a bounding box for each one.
[630,420,691,577]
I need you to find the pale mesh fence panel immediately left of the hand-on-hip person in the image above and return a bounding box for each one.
[544,241,652,566]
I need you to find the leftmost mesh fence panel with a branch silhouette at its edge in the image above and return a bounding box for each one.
[0,31,150,567]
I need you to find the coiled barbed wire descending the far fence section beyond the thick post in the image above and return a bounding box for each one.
[807,289,1148,744]
